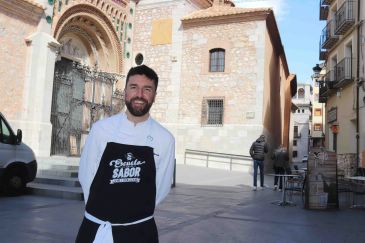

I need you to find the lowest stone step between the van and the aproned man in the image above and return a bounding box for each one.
[27,182,84,201]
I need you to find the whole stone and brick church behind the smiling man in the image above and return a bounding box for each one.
[0,0,296,169]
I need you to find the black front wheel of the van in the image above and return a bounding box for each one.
[5,169,25,196]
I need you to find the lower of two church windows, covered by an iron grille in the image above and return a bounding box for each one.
[202,97,224,126]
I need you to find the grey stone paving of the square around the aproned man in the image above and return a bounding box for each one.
[0,165,365,243]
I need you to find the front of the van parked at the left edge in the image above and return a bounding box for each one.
[0,112,37,195]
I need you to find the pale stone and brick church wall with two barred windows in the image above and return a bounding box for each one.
[133,1,296,169]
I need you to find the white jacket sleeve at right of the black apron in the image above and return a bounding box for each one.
[156,137,175,206]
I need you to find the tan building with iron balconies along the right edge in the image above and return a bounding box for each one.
[319,0,365,174]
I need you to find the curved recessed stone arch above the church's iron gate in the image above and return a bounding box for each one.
[54,4,123,73]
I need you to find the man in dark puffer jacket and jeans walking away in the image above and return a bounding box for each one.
[250,135,268,191]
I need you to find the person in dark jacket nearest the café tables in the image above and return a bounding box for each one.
[271,144,290,191]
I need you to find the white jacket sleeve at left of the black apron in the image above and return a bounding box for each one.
[78,126,100,204]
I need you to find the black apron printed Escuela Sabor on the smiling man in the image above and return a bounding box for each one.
[76,142,158,243]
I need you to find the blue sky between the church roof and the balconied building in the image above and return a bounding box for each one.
[235,0,325,83]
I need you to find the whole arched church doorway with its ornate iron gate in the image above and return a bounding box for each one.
[51,4,124,156]
